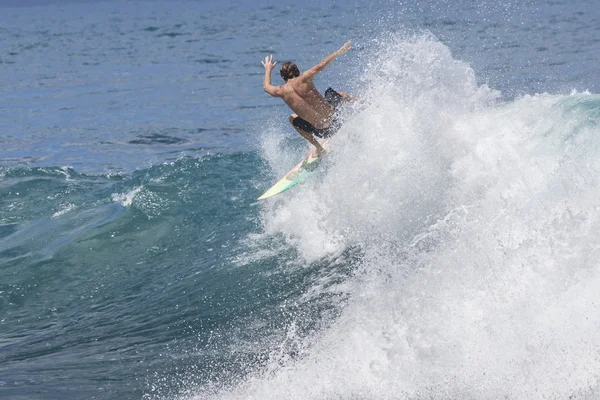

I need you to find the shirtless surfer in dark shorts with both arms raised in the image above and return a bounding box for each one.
[262,41,353,156]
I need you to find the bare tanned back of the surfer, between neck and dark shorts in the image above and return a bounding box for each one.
[280,77,333,129]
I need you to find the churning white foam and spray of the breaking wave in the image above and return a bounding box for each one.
[209,35,600,399]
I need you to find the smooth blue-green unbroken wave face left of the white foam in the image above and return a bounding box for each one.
[0,154,279,399]
